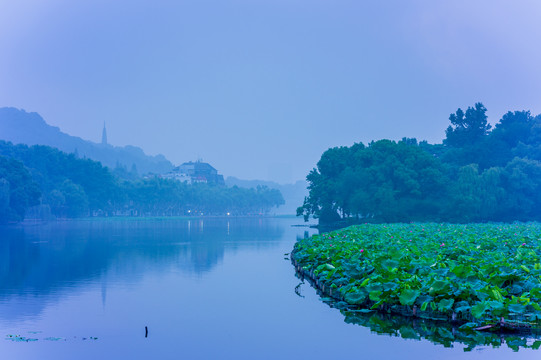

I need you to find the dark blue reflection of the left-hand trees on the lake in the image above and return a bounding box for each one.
[0,219,285,317]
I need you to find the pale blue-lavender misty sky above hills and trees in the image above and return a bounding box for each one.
[0,0,541,183]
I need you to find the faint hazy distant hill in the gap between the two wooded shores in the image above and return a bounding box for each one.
[225,176,308,215]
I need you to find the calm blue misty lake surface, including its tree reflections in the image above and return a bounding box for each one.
[0,218,540,360]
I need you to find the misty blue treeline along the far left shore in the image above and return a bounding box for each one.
[0,141,284,223]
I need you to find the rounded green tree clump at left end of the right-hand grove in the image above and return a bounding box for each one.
[298,139,448,223]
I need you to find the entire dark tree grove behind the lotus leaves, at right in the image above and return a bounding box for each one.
[297,103,541,224]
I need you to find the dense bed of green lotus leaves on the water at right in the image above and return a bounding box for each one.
[291,223,541,330]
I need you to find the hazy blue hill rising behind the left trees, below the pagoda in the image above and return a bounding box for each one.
[0,107,173,174]
